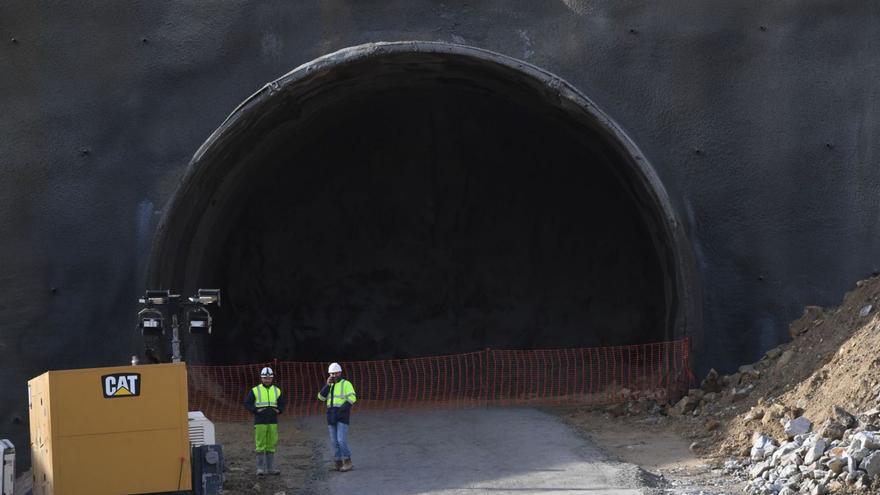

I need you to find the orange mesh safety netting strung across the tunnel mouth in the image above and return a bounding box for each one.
[188,339,693,421]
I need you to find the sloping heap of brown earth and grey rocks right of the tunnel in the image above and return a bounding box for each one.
[609,275,880,494]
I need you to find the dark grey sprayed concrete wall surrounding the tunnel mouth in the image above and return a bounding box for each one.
[0,0,880,472]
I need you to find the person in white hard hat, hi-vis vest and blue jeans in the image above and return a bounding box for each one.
[318,363,357,472]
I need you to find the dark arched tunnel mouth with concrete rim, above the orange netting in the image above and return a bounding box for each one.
[149,42,699,364]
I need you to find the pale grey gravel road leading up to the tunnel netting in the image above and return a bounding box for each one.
[305,408,647,495]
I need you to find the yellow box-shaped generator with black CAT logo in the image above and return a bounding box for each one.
[28,363,192,495]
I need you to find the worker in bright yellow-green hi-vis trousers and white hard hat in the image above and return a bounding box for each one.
[244,366,286,476]
